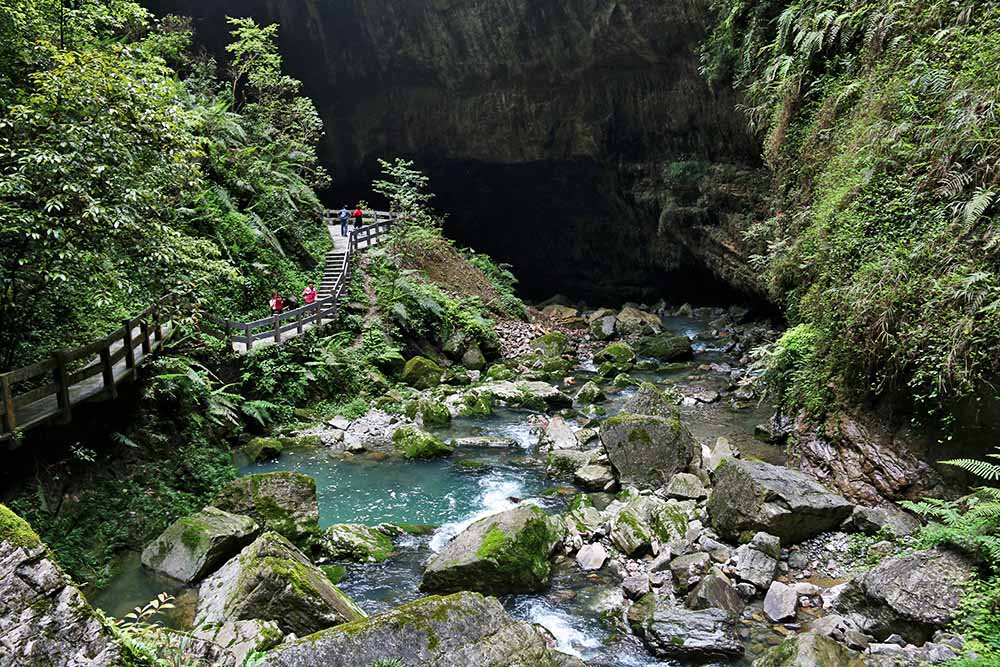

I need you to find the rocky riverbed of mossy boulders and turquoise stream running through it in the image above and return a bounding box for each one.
[0,305,972,667]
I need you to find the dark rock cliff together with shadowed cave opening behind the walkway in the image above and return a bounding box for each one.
[150,0,759,300]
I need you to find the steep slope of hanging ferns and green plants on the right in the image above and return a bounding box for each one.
[703,0,1000,426]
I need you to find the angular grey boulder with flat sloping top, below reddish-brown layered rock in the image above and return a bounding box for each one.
[708,460,854,545]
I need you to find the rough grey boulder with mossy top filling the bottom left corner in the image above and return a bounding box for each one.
[0,505,146,667]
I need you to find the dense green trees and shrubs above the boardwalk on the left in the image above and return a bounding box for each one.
[0,0,327,370]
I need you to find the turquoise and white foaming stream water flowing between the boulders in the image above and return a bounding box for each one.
[92,318,783,667]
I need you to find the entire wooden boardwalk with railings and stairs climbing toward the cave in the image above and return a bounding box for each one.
[0,211,393,444]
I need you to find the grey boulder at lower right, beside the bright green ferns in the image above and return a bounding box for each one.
[836,548,975,644]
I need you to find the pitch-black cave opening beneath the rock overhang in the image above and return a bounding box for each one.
[329,156,763,307]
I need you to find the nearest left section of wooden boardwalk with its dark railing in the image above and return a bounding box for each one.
[0,297,173,441]
